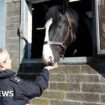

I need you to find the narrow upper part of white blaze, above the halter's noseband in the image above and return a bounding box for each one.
[44,18,52,41]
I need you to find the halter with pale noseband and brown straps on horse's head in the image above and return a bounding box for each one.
[44,12,75,57]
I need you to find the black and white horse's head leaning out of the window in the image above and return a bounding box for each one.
[43,7,78,64]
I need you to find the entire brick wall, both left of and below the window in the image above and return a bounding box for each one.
[6,0,105,105]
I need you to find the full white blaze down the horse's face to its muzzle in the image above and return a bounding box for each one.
[43,18,54,64]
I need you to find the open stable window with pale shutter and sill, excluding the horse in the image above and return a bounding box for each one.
[20,0,105,63]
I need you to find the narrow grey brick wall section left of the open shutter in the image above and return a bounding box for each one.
[5,0,20,71]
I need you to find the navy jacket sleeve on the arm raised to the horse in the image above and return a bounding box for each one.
[19,69,49,99]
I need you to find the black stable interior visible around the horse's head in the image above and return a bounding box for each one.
[31,0,93,58]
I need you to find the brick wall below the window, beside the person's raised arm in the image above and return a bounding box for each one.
[17,62,105,105]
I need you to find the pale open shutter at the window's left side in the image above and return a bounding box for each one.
[19,0,32,63]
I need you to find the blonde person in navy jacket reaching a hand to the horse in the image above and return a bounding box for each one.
[0,48,57,105]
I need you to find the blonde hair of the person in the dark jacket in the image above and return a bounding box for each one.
[0,48,9,65]
